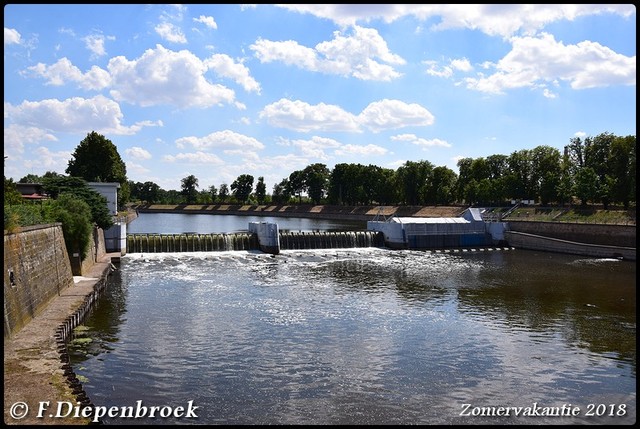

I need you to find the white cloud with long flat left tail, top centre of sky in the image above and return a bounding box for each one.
[250,26,405,81]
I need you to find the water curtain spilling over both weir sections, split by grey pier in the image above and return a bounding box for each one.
[127,231,384,253]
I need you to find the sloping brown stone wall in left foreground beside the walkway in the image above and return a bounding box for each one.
[4,223,73,337]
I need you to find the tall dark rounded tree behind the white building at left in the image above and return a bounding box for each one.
[65,131,130,207]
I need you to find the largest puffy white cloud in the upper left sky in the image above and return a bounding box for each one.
[107,45,235,108]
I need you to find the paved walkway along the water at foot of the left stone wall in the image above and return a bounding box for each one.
[4,253,120,425]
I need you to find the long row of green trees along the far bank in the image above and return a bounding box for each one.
[128,133,636,209]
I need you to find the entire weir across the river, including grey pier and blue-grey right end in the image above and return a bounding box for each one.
[127,208,506,255]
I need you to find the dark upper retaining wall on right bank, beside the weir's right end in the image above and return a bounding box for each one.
[508,221,636,247]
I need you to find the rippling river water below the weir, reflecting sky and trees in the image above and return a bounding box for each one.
[74,249,636,424]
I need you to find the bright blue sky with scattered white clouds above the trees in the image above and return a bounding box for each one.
[4,4,636,193]
